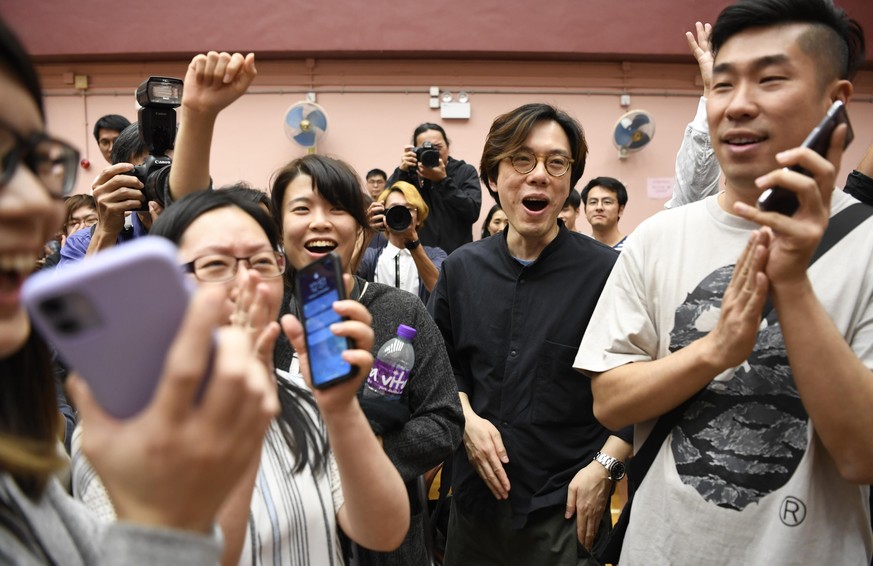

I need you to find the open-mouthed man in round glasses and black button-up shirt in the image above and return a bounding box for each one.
[428,104,631,566]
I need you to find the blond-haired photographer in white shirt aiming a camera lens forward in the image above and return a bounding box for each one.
[358,181,446,304]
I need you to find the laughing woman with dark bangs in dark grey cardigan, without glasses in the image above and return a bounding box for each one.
[271,155,463,566]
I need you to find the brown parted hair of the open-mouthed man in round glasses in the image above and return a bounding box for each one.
[479,103,588,204]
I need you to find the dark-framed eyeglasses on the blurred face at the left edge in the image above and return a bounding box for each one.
[0,123,79,198]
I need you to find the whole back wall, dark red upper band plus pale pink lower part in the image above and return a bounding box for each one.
[10,0,873,240]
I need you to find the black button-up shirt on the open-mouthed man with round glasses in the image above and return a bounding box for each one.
[428,226,629,528]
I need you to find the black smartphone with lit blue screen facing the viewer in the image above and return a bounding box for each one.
[295,252,357,388]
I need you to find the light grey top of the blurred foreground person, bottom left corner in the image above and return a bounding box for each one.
[0,473,221,566]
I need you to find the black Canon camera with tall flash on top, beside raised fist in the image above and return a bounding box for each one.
[128,77,182,212]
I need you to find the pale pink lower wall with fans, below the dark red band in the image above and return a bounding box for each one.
[40,60,873,240]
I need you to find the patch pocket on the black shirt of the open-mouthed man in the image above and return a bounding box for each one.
[532,340,594,426]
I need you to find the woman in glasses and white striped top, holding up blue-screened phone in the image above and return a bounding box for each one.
[73,188,408,565]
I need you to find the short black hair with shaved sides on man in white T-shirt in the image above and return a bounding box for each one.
[712,0,866,87]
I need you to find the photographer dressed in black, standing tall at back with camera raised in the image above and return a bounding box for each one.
[388,122,482,254]
